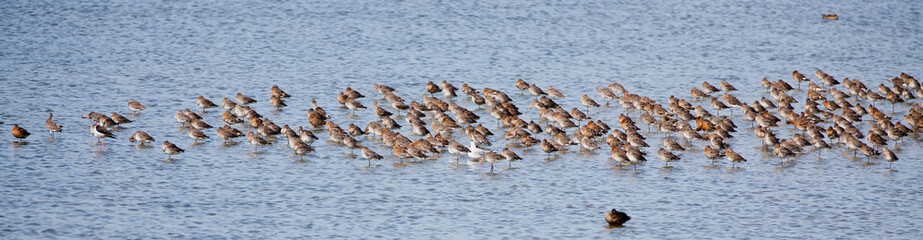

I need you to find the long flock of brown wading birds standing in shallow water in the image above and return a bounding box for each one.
[12,70,923,171]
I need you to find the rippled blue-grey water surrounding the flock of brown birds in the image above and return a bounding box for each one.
[0,1,923,239]
